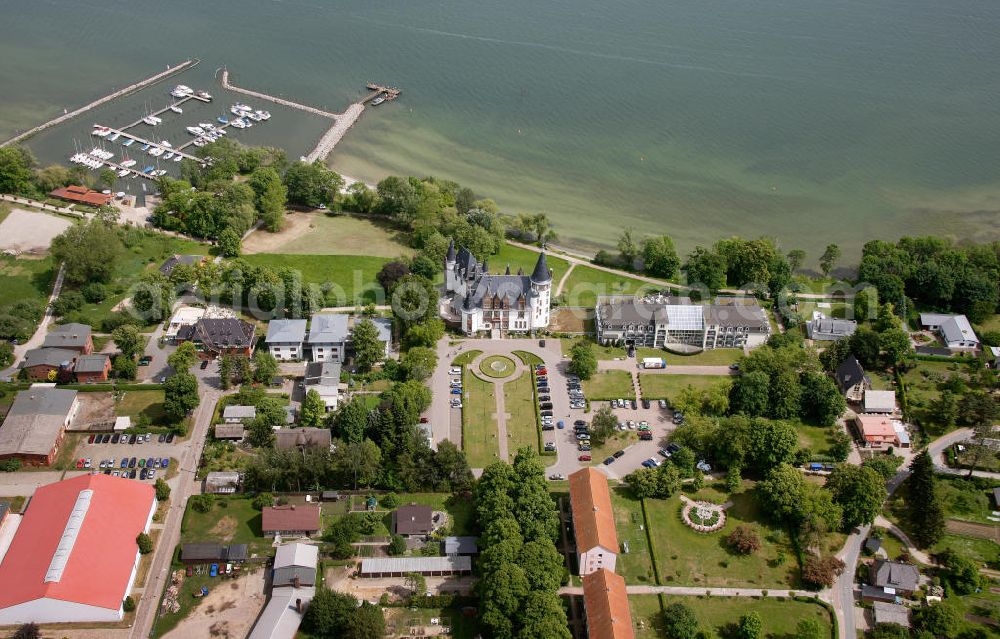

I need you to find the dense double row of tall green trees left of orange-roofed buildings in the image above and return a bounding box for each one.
[476,448,570,639]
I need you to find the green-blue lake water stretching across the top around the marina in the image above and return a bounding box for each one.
[0,0,1000,261]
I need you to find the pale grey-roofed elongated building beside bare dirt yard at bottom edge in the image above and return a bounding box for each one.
[248,543,319,639]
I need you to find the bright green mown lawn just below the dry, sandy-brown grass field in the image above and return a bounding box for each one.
[242,253,389,306]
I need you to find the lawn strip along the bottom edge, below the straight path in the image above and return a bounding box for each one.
[628,595,832,639]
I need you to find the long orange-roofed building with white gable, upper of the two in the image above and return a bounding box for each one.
[569,468,618,575]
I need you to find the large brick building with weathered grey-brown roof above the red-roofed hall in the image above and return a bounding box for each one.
[0,384,80,466]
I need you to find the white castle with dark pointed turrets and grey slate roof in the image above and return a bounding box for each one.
[441,241,552,335]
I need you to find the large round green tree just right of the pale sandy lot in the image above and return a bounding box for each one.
[51,220,124,284]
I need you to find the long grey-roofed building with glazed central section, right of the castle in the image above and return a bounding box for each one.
[595,296,771,350]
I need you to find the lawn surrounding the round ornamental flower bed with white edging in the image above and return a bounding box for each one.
[646,482,799,588]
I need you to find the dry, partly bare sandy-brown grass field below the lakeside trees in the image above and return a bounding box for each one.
[247,213,413,258]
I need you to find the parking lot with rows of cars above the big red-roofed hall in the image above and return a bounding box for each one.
[74,433,181,481]
